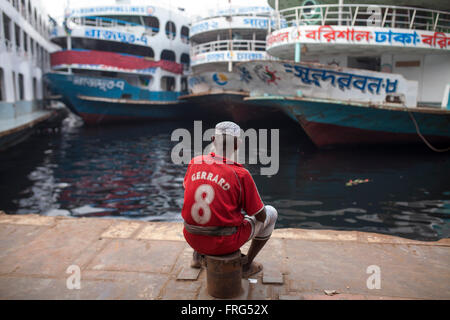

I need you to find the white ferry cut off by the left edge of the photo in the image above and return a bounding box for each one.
[0,0,57,150]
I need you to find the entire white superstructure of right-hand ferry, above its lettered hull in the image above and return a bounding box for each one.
[267,0,450,105]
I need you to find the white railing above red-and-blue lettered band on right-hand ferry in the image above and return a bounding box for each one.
[269,4,450,32]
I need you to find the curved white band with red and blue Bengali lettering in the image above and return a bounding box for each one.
[267,26,450,53]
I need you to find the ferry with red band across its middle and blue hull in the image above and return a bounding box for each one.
[46,2,192,124]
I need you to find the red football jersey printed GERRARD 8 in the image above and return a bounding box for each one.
[182,153,264,255]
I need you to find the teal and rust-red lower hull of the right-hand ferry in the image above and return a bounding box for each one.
[250,98,450,148]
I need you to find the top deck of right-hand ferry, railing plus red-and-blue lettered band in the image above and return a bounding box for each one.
[267,0,450,59]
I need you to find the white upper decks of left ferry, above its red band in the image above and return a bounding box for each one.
[51,5,189,62]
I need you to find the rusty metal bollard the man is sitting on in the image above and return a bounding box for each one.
[205,250,245,299]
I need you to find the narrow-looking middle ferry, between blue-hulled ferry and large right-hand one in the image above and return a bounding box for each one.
[182,4,288,123]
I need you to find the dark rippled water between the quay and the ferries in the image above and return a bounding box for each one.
[0,116,450,240]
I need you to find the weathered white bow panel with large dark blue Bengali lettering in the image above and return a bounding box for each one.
[237,61,418,107]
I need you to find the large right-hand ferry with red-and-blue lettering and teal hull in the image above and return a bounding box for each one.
[243,0,450,151]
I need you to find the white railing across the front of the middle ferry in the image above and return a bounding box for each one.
[191,40,266,55]
